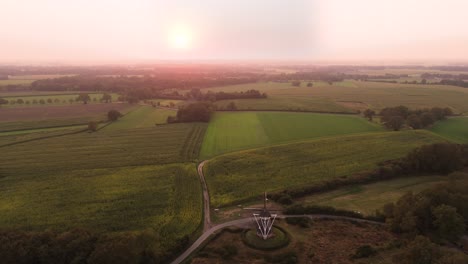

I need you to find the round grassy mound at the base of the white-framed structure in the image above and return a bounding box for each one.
[242,226,289,250]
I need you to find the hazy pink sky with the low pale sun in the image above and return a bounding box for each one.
[0,0,468,63]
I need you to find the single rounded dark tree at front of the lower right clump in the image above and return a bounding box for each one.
[431,204,466,242]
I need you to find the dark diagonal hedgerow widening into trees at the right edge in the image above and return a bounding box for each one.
[270,143,468,205]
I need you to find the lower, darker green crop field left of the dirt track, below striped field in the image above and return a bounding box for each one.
[0,163,203,253]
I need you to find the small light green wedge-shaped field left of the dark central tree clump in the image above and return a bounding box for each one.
[103,106,177,131]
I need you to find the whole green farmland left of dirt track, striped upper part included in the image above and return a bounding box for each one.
[0,123,206,258]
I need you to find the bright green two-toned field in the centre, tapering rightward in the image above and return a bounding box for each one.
[201,112,382,158]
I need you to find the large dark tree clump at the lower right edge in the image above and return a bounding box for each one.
[382,173,468,242]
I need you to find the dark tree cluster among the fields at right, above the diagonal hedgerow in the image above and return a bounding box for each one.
[376,106,453,131]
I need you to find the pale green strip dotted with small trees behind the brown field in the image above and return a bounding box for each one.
[2,93,119,108]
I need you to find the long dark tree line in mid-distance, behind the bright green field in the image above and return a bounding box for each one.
[184,89,267,102]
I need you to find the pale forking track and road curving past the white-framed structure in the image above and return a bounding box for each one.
[171,160,383,264]
